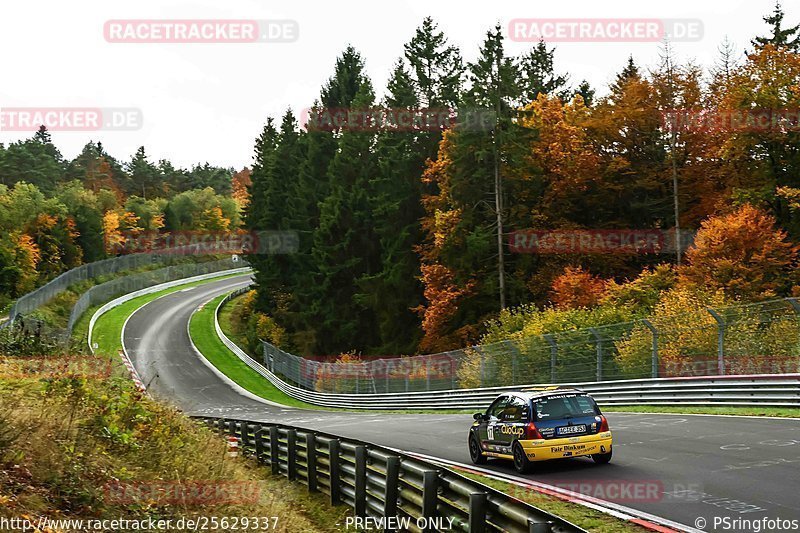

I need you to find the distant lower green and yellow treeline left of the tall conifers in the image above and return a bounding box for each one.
[0,127,250,307]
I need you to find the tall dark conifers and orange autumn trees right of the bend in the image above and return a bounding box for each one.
[246,6,800,354]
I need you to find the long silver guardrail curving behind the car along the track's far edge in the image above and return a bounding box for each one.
[215,287,800,410]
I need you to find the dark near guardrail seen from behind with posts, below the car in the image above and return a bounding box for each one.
[198,417,584,533]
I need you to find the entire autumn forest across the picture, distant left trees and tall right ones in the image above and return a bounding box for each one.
[6,5,800,362]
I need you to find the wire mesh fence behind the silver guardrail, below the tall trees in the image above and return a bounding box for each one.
[262,298,800,394]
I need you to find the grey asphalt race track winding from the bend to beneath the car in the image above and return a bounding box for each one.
[123,276,800,531]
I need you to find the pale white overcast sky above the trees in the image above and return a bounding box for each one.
[0,0,800,168]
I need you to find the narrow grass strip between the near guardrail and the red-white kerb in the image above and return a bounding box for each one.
[452,468,648,533]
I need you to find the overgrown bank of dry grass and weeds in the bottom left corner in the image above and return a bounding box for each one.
[0,362,349,533]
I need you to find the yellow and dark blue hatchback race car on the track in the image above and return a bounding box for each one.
[468,387,612,474]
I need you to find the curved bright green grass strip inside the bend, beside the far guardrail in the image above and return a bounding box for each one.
[189,295,323,409]
